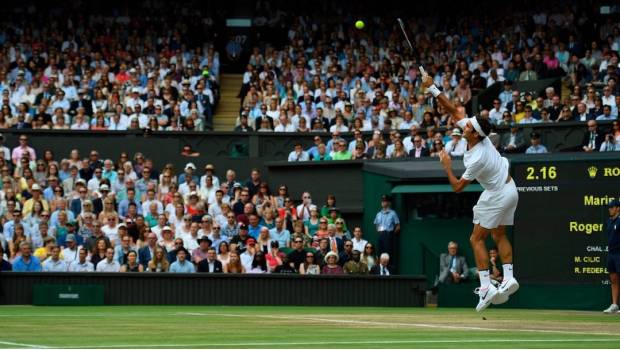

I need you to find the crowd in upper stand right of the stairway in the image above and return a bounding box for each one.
[235,3,620,156]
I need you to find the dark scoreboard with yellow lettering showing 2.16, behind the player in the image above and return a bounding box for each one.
[512,157,620,284]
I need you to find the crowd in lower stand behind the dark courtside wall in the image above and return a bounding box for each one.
[0,135,389,274]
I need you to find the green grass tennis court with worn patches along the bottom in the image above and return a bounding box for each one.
[0,306,620,348]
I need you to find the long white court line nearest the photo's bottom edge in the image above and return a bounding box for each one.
[54,338,618,349]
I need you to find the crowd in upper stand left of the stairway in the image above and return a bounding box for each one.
[0,2,220,131]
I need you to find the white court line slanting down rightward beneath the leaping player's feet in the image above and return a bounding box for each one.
[173,312,619,336]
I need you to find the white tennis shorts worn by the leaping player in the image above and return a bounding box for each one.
[474,179,519,229]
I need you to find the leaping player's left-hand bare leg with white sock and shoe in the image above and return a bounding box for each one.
[469,224,498,311]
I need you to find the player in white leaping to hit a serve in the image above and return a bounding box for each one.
[422,73,519,311]
